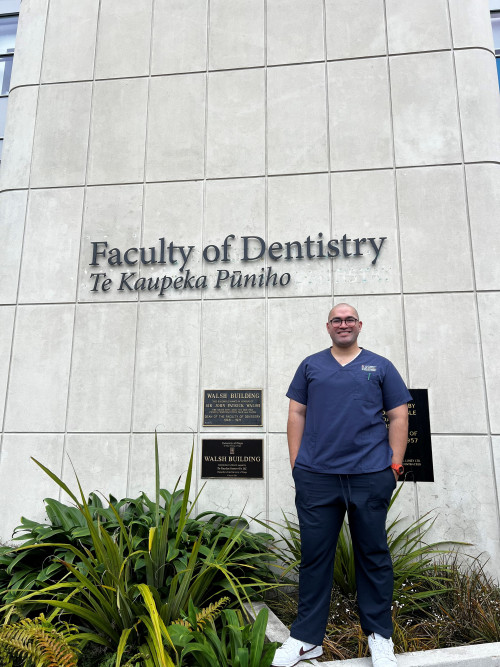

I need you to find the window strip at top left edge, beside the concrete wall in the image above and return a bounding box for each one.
[0,0,20,162]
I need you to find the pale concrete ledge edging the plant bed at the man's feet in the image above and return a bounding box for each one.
[245,602,500,667]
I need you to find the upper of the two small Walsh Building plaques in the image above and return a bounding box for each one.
[203,389,262,426]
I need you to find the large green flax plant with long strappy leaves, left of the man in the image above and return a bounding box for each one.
[0,436,275,667]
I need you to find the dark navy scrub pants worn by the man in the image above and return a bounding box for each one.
[290,467,396,645]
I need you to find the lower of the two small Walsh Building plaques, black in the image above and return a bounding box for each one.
[201,439,264,479]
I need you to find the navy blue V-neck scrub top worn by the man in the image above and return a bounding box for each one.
[286,348,412,474]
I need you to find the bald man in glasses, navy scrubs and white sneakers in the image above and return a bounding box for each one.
[273,303,411,667]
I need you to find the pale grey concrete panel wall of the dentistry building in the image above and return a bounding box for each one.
[0,0,500,565]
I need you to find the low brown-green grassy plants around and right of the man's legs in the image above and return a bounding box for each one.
[268,522,500,660]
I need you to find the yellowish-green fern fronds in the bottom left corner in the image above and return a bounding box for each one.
[0,614,79,667]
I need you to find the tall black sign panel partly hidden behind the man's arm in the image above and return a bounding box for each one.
[386,389,434,482]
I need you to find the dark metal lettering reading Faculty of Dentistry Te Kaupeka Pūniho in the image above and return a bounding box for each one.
[89,232,387,298]
